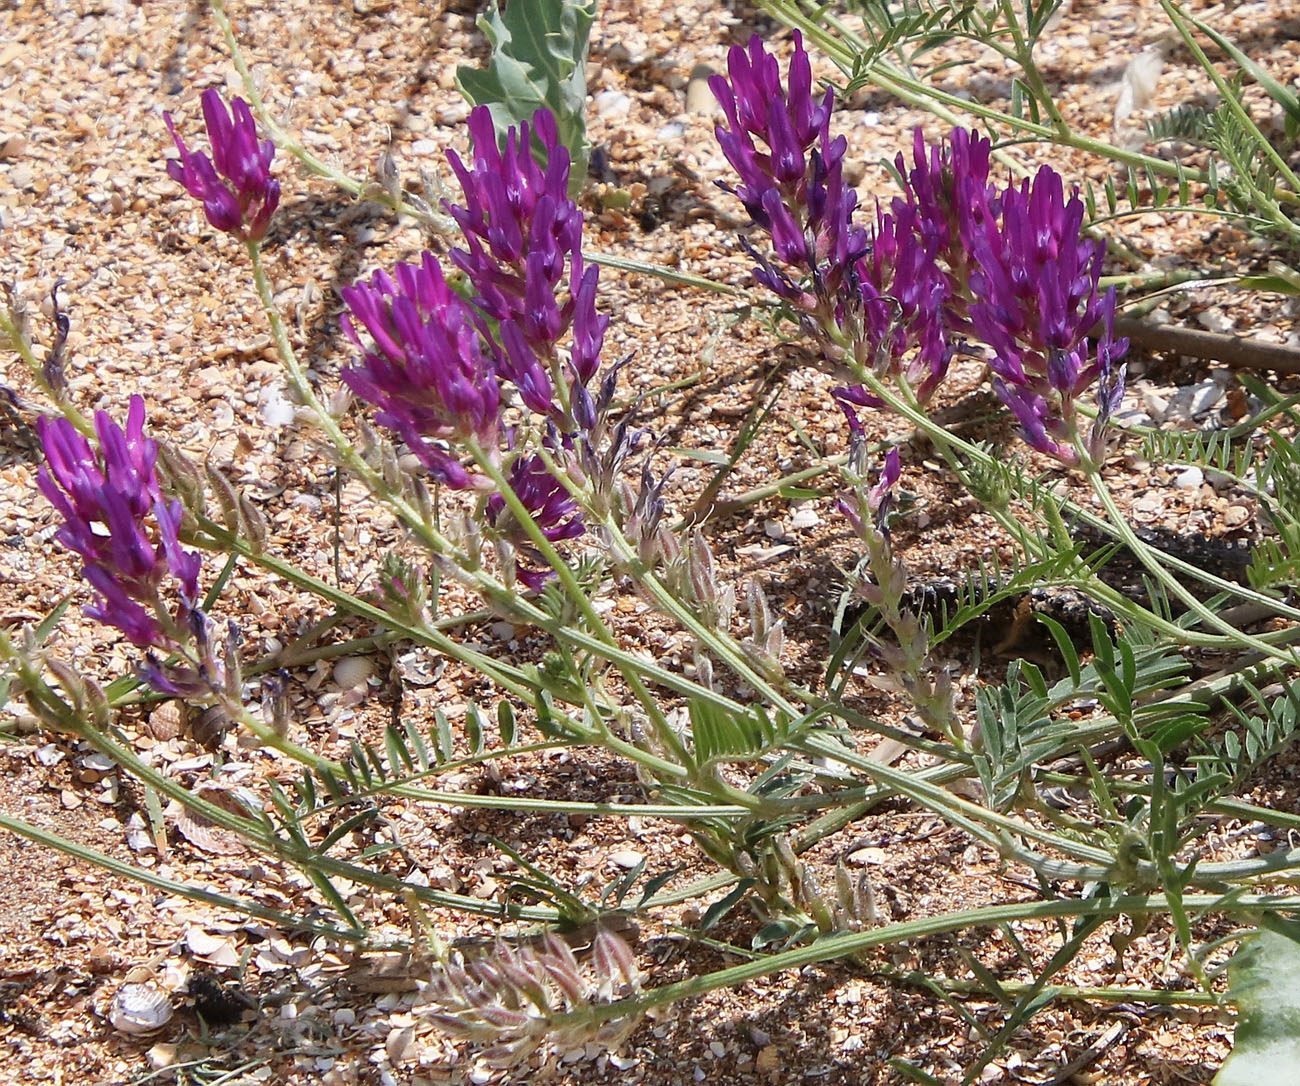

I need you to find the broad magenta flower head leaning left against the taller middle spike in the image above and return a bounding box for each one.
[341,252,501,489]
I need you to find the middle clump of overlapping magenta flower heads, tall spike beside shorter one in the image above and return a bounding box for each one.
[343,107,608,587]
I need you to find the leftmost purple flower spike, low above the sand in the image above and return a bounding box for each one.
[36,395,202,648]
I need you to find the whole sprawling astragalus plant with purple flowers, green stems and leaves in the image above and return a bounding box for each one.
[0,12,1300,1081]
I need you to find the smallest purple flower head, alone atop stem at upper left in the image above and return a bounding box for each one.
[163,88,280,242]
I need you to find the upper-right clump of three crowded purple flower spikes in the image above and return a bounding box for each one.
[711,34,1128,464]
